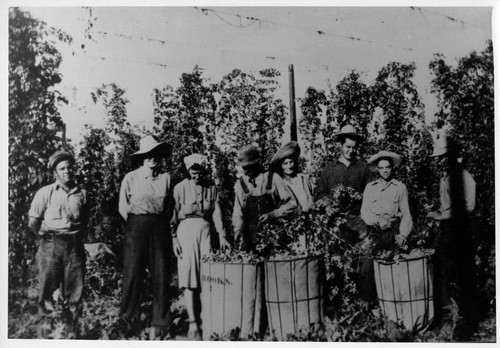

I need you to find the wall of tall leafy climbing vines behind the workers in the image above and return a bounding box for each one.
[9,8,495,340]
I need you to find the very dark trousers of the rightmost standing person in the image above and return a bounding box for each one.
[433,219,479,322]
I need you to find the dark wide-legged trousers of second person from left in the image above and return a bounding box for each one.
[120,215,172,330]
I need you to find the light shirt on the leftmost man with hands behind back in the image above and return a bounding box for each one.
[29,182,88,235]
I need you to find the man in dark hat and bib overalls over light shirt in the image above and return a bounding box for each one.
[233,145,297,251]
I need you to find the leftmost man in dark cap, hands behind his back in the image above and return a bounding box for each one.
[28,151,88,320]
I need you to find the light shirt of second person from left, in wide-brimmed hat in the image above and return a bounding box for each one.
[118,166,170,220]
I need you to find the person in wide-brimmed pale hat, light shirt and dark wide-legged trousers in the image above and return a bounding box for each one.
[118,136,172,339]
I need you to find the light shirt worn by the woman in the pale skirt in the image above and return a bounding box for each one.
[172,179,226,236]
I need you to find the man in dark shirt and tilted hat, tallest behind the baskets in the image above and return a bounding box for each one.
[316,124,372,243]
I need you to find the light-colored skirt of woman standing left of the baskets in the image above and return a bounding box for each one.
[177,218,211,288]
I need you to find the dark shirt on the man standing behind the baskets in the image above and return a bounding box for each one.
[316,160,372,200]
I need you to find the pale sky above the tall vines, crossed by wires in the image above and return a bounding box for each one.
[16,4,492,142]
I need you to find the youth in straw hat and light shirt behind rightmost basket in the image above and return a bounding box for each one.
[361,151,413,301]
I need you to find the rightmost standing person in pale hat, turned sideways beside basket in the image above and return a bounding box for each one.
[427,135,478,338]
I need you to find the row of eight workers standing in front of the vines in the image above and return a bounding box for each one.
[29,124,475,340]
